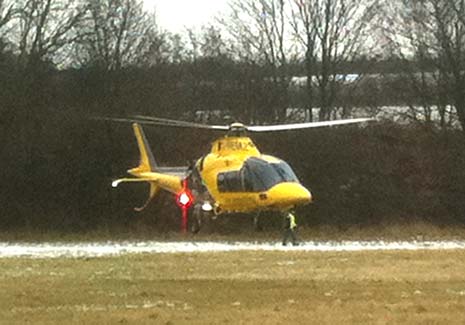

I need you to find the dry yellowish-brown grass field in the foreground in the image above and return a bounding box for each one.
[0,250,465,324]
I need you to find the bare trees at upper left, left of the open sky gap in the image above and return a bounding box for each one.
[0,0,157,72]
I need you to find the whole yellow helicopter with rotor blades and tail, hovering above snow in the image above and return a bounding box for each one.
[111,115,371,232]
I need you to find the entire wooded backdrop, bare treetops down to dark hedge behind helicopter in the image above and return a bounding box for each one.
[0,0,465,231]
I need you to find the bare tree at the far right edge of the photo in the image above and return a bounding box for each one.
[385,0,465,130]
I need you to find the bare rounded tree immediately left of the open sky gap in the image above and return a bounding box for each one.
[77,0,156,70]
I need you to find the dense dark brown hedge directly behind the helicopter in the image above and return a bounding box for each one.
[1,115,465,232]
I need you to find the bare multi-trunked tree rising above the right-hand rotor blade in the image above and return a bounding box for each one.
[290,0,378,120]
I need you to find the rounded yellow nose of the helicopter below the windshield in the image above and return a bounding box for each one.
[266,183,312,208]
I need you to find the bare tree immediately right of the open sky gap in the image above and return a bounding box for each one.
[222,0,293,122]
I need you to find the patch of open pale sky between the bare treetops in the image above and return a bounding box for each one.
[144,0,227,33]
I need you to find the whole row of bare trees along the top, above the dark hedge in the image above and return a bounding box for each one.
[0,0,465,127]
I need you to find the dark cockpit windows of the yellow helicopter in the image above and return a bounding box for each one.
[218,157,298,192]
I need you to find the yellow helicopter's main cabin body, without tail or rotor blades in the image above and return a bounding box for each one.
[195,135,312,214]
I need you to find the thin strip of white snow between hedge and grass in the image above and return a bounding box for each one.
[0,241,465,258]
